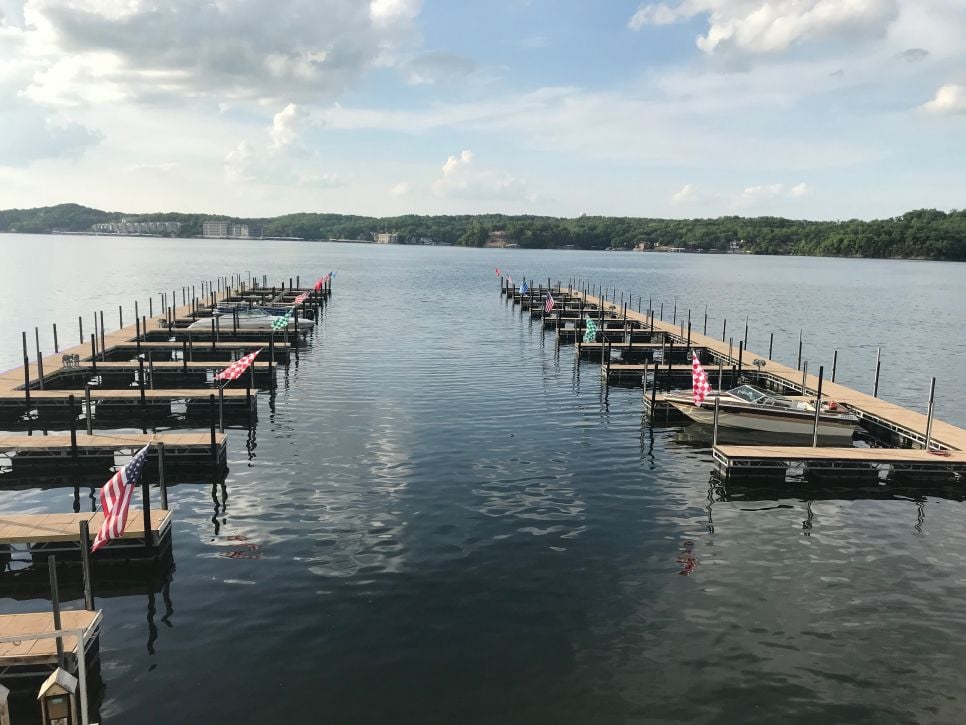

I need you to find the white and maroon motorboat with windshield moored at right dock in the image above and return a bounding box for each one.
[664,385,859,438]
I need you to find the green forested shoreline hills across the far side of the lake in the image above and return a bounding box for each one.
[0,204,966,260]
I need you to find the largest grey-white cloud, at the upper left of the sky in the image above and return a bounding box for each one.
[11,0,421,104]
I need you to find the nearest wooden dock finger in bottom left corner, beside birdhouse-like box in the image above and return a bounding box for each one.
[0,609,103,687]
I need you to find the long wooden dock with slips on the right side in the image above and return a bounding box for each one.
[501,282,966,480]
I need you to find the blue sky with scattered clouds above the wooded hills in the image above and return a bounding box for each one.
[0,0,966,219]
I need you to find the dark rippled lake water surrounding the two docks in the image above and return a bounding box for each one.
[0,235,966,724]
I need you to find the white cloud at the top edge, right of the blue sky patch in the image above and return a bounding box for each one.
[628,0,899,55]
